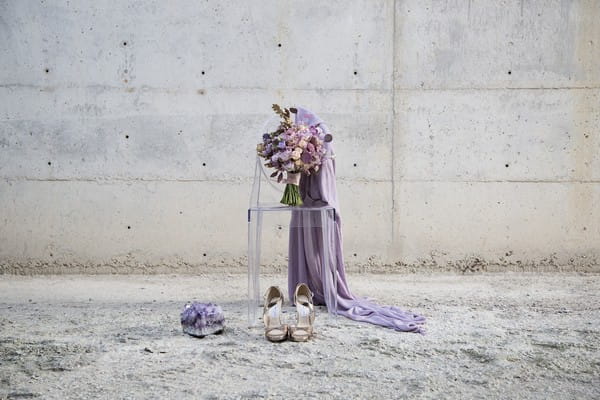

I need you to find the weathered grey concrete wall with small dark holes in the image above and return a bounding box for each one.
[0,0,600,273]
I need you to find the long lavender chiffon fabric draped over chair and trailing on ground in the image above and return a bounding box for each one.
[288,108,425,333]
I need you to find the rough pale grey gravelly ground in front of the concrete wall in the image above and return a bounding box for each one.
[0,273,600,399]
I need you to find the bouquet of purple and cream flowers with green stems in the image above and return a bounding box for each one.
[256,104,326,206]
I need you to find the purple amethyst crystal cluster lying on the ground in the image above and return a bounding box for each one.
[181,302,225,337]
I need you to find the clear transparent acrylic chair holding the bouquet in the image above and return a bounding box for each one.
[248,118,337,326]
